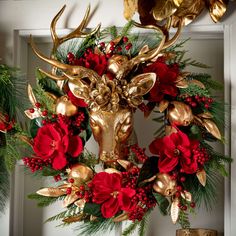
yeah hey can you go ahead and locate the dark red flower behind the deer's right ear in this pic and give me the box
[144,59,179,102]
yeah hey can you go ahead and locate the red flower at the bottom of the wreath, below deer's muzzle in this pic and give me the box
[92,172,135,218]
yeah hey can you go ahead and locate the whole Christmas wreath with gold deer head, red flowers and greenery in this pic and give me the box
[1,4,231,235]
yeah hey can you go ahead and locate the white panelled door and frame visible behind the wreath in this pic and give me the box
[0,0,236,236]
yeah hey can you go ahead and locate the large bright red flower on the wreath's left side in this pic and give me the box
[34,119,83,170]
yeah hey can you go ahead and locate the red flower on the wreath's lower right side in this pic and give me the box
[149,131,199,174]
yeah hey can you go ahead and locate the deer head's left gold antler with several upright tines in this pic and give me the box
[30,5,101,81]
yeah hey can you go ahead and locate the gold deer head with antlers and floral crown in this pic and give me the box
[31,6,182,164]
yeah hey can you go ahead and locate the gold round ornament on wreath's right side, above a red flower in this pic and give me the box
[167,101,194,126]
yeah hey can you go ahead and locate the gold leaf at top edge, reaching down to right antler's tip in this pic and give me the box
[172,0,205,27]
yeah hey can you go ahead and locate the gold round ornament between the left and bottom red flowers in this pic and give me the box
[68,164,93,186]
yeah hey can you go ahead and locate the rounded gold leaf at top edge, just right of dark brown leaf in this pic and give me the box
[152,0,183,21]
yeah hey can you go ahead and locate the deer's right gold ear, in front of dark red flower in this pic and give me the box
[126,73,156,107]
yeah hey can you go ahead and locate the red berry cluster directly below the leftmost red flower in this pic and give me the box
[23,157,52,172]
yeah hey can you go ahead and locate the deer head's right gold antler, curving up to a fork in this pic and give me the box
[116,17,183,79]
